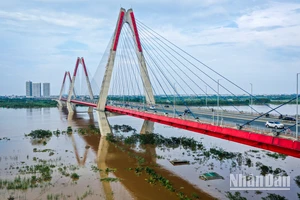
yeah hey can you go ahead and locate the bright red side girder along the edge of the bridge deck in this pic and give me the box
[62,99,300,158]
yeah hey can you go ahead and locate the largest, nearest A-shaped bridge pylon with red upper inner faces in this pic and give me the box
[97,8,155,111]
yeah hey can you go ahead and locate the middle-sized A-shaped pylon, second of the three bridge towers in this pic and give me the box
[67,57,94,113]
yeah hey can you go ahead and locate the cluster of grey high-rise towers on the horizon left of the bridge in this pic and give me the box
[26,81,50,97]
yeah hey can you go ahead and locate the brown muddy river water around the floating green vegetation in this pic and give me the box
[0,108,300,200]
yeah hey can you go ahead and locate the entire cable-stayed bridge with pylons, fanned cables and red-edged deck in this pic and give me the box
[58,8,300,157]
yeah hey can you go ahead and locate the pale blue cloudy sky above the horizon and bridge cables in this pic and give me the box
[0,0,300,95]
